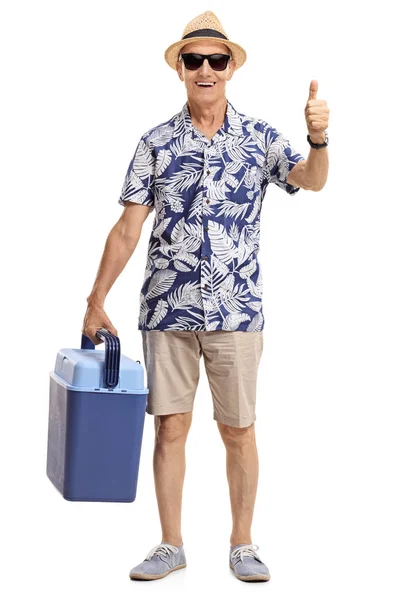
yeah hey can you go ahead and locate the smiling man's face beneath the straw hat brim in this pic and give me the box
[176,40,236,104]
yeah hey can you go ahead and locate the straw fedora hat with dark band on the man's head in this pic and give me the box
[164,10,246,71]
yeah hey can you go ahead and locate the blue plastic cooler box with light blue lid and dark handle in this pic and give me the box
[47,328,149,502]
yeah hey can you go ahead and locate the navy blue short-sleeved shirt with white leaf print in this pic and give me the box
[118,99,305,331]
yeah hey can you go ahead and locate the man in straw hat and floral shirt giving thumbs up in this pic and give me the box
[83,11,329,581]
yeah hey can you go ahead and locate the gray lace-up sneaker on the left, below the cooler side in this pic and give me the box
[129,542,186,579]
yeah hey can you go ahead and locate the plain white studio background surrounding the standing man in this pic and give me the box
[0,0,400,600]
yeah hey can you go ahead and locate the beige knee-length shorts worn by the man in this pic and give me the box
[141,329,263,427]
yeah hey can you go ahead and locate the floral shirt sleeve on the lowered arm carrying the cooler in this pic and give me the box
[118,134,156,212]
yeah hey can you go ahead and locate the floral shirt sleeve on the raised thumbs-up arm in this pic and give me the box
[266,127,306,195]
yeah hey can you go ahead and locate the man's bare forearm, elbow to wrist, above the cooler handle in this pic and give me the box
[87,223,139,306]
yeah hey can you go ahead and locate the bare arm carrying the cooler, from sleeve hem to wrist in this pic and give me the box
[87,202,151,307]
